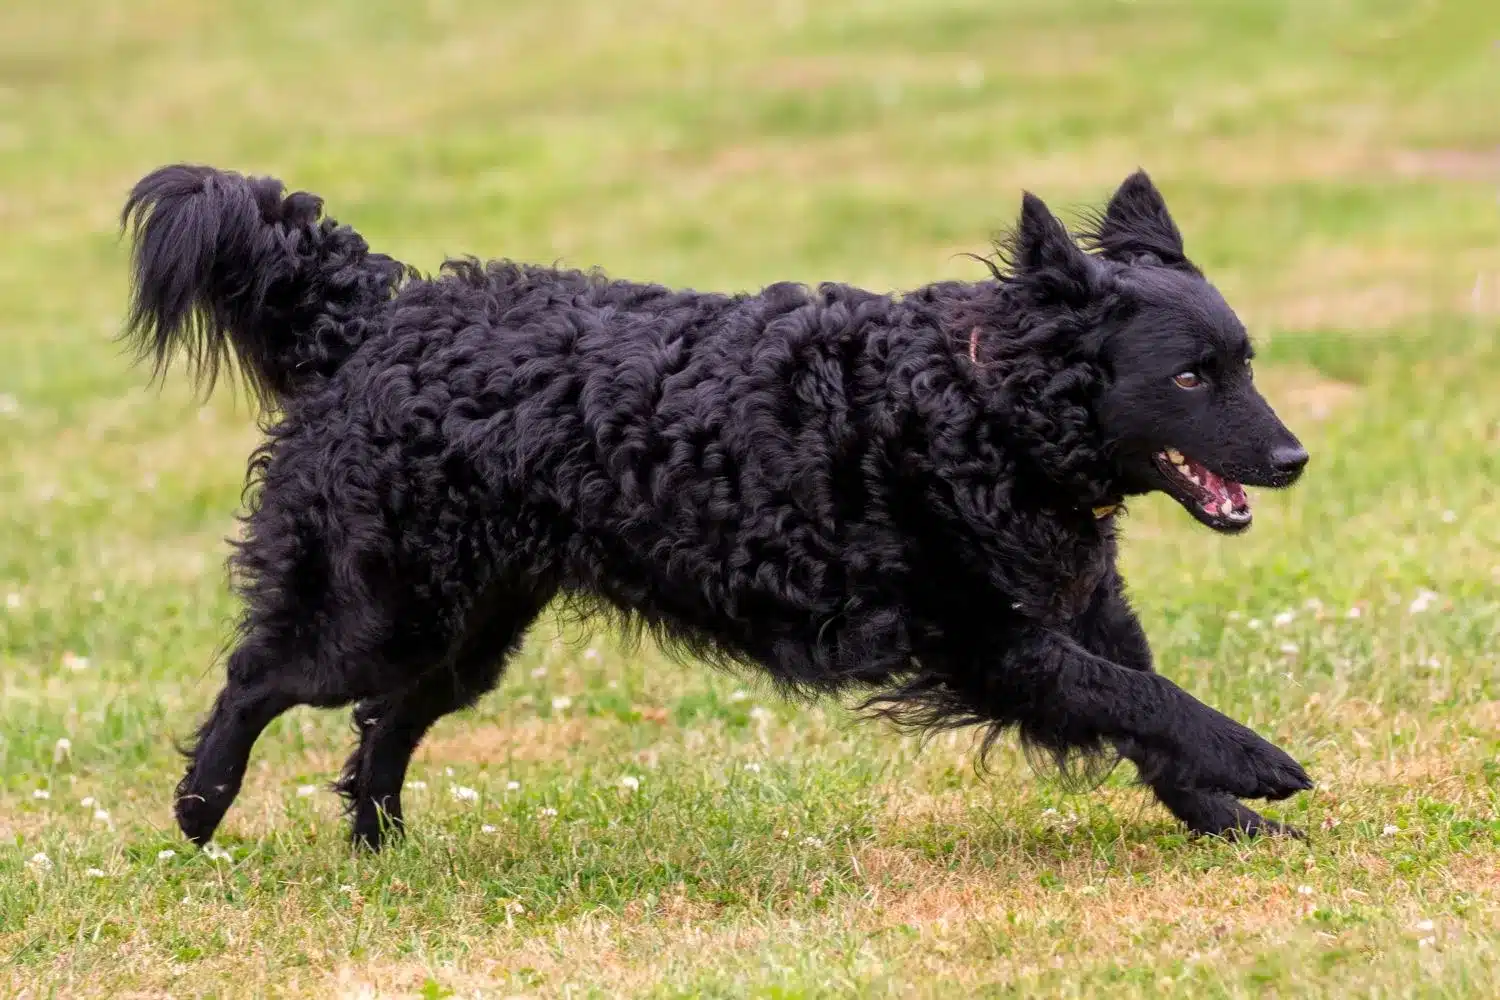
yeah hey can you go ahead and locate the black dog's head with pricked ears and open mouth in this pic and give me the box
[1013,172,1308,532]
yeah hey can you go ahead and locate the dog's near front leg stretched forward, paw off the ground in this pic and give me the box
[984,627,1313,803]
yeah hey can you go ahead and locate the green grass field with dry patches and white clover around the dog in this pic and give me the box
[0,0,1500,999]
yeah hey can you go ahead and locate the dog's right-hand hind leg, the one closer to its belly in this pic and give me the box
[339,597,546,850]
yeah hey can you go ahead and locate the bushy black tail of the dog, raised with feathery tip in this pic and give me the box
[120,165,413,405]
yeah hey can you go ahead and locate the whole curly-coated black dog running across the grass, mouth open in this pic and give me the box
[125,166,1311,846]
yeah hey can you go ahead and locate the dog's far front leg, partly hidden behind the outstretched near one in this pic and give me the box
[1073,573,1302,837]
